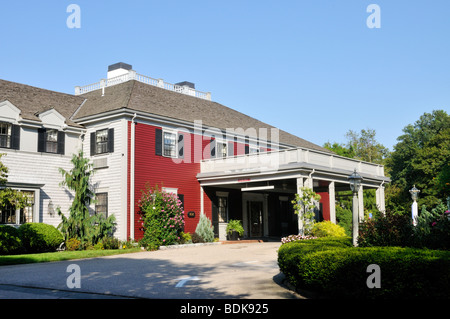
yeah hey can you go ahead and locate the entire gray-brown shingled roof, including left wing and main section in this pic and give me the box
[0,79,332,153]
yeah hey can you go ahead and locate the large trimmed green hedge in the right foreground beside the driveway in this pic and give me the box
[278,238,450,299]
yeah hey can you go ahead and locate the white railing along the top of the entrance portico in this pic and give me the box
[201,148,384,177]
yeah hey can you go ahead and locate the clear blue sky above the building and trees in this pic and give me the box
[0,0,450,150]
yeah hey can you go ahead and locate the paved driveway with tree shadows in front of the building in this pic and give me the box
[0,242,299,299]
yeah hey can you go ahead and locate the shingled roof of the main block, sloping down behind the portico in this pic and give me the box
[74,80,332,153]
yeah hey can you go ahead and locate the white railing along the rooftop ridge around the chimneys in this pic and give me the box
[75,70,211,101]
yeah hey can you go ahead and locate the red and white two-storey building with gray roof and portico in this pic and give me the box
[0,63,389,240]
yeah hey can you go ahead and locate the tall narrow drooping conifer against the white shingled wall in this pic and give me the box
[57,151,115,245]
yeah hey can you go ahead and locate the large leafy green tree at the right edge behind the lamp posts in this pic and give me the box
[386,110,450,207]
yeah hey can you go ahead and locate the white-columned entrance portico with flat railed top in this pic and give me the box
[197,148,389,239]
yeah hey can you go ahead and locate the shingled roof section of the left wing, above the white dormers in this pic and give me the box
[0,79,85,127]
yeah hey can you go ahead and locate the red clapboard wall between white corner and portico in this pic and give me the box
[128,122,212,240]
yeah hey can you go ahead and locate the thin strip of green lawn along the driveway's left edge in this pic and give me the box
[0,248,142,266]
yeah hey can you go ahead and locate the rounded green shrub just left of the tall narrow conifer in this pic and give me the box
[19,223,64,253]
